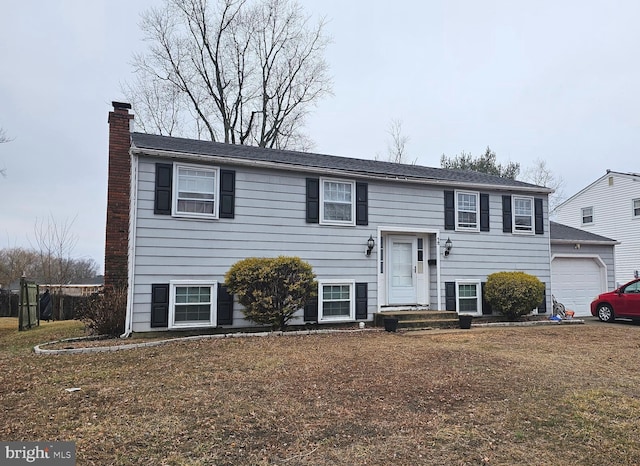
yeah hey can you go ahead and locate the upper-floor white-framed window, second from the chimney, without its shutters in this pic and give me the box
[320,180,355,225]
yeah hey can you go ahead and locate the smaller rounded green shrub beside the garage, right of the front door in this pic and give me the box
[485,272,544,320]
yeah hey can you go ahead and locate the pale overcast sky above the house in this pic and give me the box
[0,0,640,269]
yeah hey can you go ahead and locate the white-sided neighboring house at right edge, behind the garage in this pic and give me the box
[555,170,640,285]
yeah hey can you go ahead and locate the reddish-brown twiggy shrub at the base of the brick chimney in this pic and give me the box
[77,288,127,337]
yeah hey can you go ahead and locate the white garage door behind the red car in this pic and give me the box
[551,257,607,317]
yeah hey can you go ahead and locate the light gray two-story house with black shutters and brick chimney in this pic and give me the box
[105,102,551,332]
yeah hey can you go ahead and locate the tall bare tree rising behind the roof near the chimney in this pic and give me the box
[124,0,331,148]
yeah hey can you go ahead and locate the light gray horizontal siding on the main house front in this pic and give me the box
[133,157,550,331]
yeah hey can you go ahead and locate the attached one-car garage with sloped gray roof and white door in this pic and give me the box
[550,222,619,317]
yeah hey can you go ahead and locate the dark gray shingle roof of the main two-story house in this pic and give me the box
[131,133,549,192]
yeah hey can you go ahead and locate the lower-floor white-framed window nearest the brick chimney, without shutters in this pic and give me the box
[169,281,217,327]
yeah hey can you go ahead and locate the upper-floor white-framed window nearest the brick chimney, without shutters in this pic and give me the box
[173,164,218,218]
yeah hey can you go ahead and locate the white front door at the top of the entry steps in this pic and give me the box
[387,236,417,304]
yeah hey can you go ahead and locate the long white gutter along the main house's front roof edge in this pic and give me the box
[131,145,554,194]
